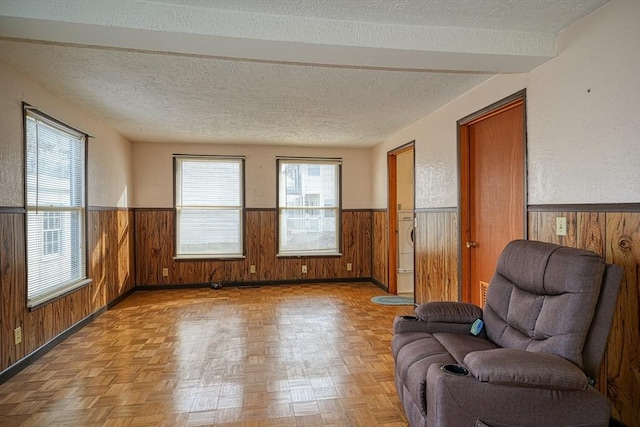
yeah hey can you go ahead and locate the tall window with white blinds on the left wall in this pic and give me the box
[24,105,90,307]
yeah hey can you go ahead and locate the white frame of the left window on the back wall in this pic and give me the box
[174,155,245,260]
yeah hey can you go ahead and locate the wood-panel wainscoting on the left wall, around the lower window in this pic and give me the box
[0,207,135,375]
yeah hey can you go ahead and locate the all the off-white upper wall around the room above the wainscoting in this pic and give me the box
[0,0,640,209]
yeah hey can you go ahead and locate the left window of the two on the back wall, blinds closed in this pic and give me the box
[175,156,244,258]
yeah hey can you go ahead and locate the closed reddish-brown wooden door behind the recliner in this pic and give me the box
[459,94,526,305]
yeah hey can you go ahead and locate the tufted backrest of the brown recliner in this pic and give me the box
[483,240,606,368]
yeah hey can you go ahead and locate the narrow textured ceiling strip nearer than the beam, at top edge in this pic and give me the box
[145,0,605,33]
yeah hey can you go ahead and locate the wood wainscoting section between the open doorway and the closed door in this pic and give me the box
[414,208,459,304]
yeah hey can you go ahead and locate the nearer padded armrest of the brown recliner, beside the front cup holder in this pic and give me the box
[464,348,589,390]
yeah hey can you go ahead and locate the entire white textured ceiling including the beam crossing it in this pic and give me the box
[0,0,606,146]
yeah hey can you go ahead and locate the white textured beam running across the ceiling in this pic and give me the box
[0,0,556,73]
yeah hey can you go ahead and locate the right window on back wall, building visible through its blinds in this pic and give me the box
[278,158,341,256]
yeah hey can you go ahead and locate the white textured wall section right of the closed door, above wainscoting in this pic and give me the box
[527,0,640,204]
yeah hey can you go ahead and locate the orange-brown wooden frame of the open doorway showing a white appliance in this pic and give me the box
[387,139,416,295]
